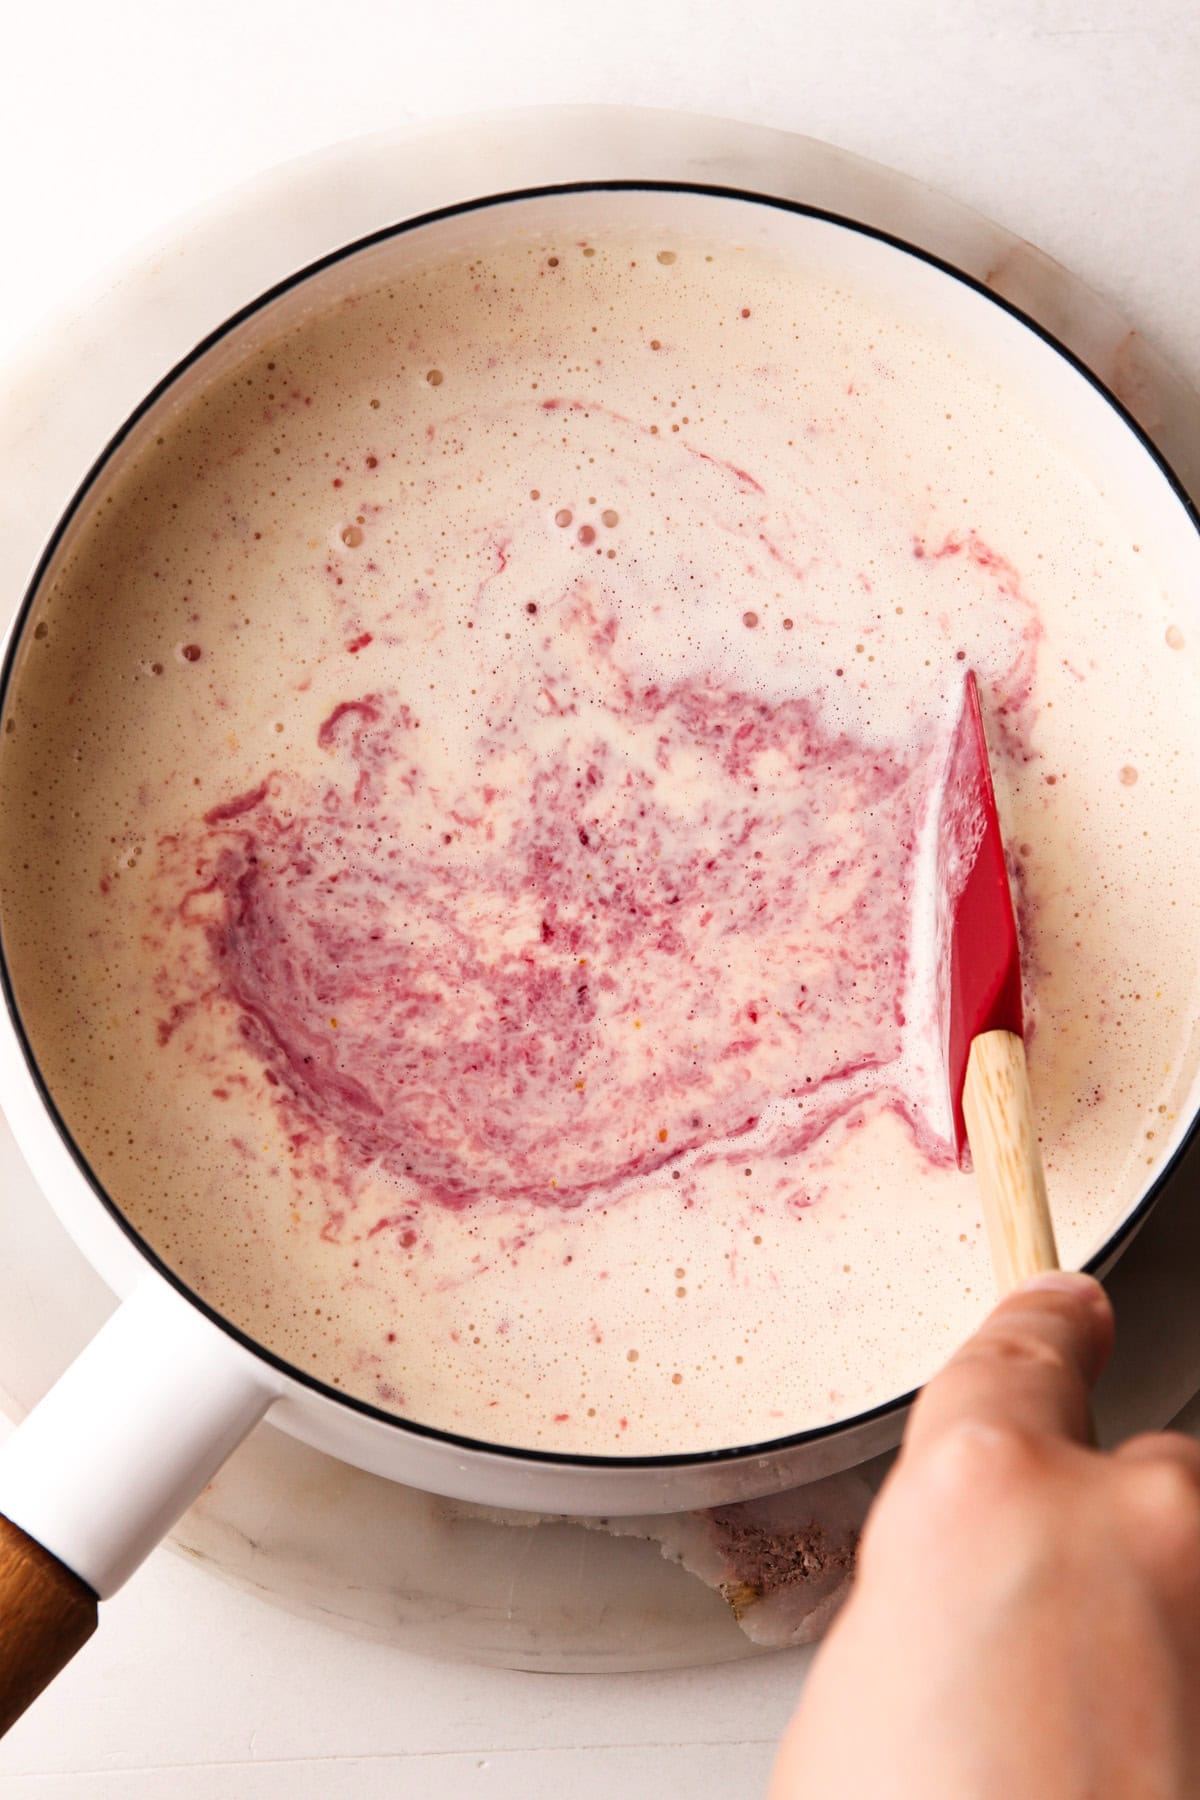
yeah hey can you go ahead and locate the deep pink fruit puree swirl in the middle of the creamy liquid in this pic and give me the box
[147,525,1036,1208]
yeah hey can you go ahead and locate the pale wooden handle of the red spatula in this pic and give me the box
[963,1031,1058,1294]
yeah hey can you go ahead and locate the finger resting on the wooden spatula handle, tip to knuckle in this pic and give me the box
[905,1274,1112,1451]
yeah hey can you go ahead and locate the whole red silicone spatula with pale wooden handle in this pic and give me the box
[937,673,1058,1294]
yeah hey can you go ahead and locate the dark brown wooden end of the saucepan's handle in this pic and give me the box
[0,1517,95,1737]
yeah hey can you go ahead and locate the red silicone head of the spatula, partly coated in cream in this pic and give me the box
[937,671,1024,1166]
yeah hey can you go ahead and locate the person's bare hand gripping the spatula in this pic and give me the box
[770,1274,1200,1800]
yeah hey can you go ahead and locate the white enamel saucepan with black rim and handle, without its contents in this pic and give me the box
[0,171,1200,1724]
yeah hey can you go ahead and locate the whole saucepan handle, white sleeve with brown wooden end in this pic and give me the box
[0,1274,279,1732]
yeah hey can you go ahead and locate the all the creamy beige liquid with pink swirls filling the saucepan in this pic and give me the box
[0,210,1200,1454]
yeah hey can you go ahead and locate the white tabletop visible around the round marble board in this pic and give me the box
[0,0,1200,1800]
